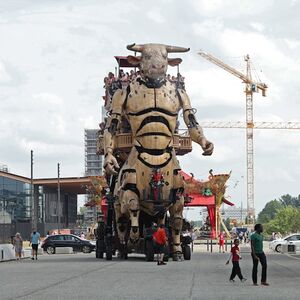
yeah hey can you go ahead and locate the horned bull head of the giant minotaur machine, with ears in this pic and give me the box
[127,44,190,79]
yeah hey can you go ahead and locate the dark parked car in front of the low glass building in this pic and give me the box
[41,234,95,254]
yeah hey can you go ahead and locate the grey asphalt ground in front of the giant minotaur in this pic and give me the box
[0,249,300,300]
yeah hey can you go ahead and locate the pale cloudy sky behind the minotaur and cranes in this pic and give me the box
[0,0,300,219]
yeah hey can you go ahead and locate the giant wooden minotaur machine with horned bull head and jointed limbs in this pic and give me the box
[102,44,213,260]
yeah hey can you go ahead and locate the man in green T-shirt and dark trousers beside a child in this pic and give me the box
[250,224,269,286]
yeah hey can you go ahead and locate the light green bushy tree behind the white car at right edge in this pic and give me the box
[265,206,300,234]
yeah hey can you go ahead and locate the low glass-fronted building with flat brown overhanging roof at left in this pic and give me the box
[0,171,90,242]
